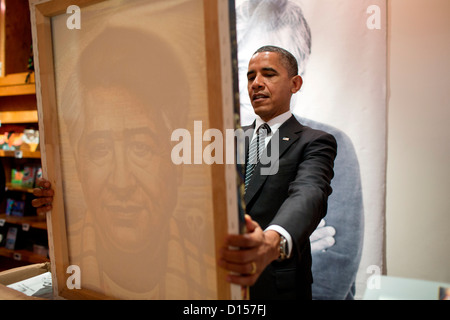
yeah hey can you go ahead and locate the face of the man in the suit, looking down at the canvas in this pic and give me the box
[247,52,301,121]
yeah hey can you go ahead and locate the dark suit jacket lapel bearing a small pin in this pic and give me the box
[244,116,303,203]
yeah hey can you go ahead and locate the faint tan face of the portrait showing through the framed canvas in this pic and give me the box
[77,88,177,252]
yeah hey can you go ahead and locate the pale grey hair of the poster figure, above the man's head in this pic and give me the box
[236,0,311,75]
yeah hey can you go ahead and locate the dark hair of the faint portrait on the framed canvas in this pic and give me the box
[62,27,190,151]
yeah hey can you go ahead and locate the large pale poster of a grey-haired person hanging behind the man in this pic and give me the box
[236,0,386,299]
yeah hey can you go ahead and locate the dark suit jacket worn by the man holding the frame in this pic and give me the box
[243,116,337,299]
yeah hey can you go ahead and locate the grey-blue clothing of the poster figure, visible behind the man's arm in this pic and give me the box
[295,116,364,300]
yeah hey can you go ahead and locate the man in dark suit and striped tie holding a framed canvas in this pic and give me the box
[219,46,337,299]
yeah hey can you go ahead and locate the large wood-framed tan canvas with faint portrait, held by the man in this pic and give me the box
[30,0,244,299]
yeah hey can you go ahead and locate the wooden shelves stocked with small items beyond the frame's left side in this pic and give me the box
[0,0,49,271]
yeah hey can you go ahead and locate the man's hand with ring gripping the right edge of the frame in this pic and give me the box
[218,215,280,286]
